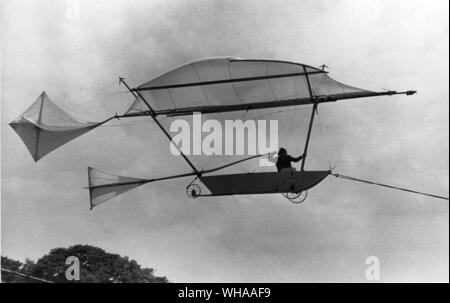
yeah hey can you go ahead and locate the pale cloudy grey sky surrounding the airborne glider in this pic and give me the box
[0,0,449,282]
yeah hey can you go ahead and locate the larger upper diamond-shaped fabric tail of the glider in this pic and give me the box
[9,92,107,162]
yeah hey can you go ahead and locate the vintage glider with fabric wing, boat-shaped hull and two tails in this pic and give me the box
[11,57,430,208]
